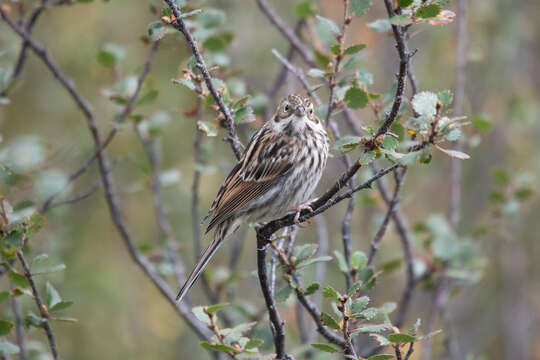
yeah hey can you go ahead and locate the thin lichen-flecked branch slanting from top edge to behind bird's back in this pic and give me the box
[165,0,244,159]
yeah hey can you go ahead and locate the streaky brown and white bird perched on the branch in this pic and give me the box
[176,94,329,302]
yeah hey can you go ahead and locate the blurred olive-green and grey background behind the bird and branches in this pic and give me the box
[0,0,540,360]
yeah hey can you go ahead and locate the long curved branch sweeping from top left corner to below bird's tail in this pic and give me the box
[0,8,215,340]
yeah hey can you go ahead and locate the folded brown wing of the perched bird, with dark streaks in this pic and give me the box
[206,128,297,232]
